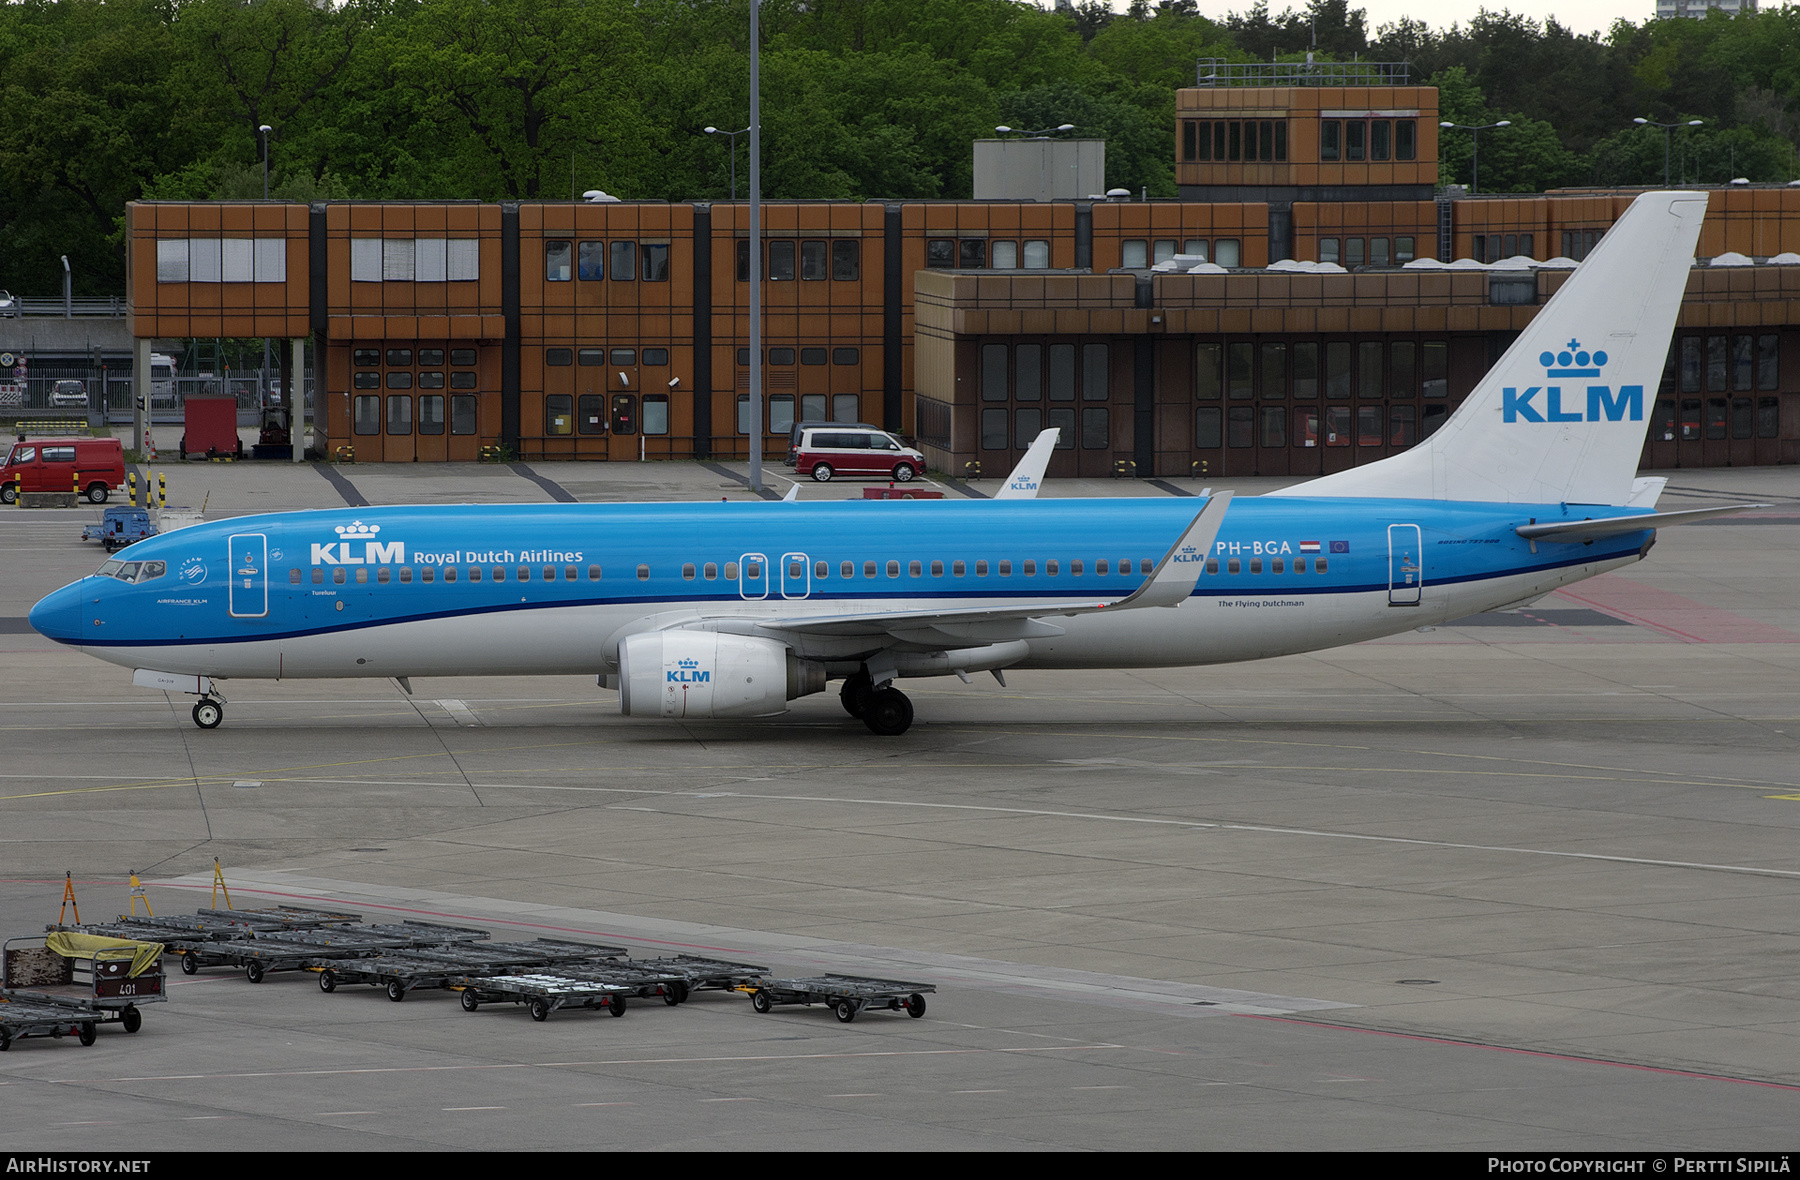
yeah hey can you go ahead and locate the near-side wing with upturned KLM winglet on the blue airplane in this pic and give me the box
[702,491,1231,644]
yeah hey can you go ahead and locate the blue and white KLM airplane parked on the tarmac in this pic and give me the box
[31,192,1742,734]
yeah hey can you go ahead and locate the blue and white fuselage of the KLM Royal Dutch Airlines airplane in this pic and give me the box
[32,498,1654,678]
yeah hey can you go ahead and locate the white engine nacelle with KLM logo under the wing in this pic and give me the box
[619,631,824,718]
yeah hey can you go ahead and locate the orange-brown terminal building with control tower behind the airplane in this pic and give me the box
[128,63,1800,477]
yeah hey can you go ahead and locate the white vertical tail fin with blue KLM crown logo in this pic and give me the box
[1269,192,1706,505]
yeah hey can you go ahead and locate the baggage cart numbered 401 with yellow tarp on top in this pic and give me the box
[0,934,169,1036]
